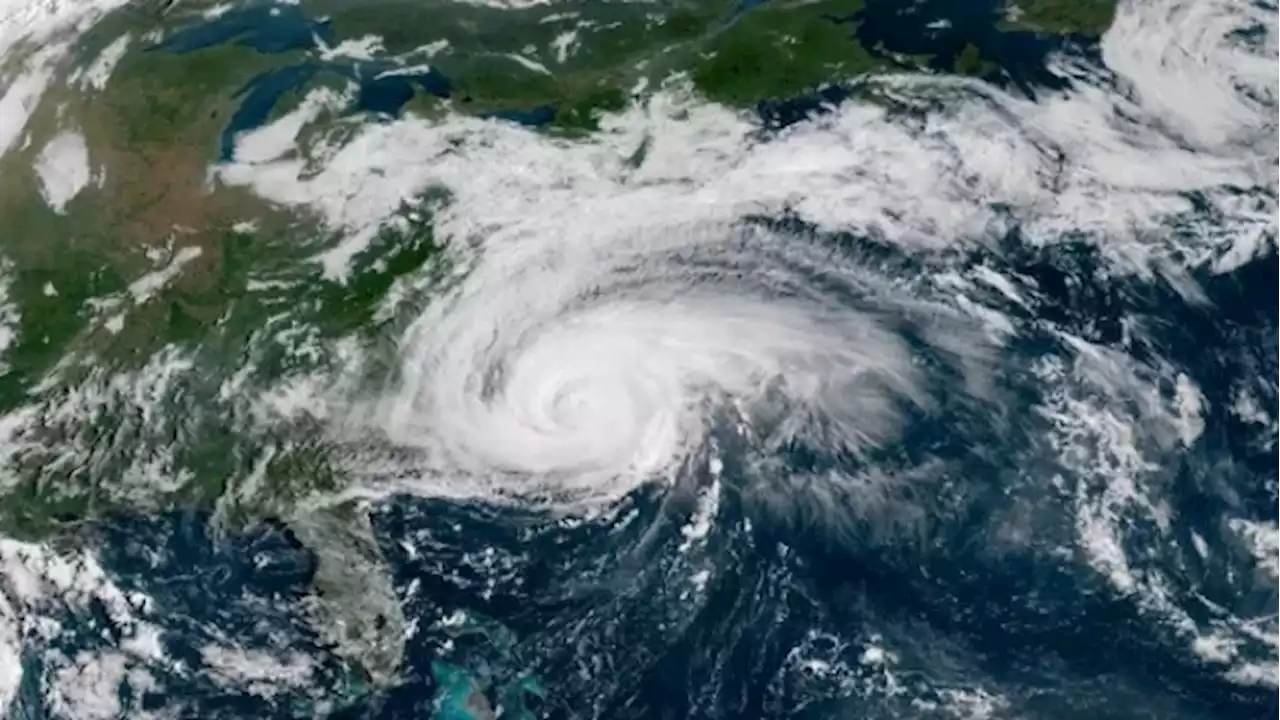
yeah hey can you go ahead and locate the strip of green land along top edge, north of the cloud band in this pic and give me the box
[316,0,1115,125]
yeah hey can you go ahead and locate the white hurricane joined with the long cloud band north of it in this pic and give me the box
[219,1,1280,532]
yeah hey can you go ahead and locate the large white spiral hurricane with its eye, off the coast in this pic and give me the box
[371,215,988,506]
